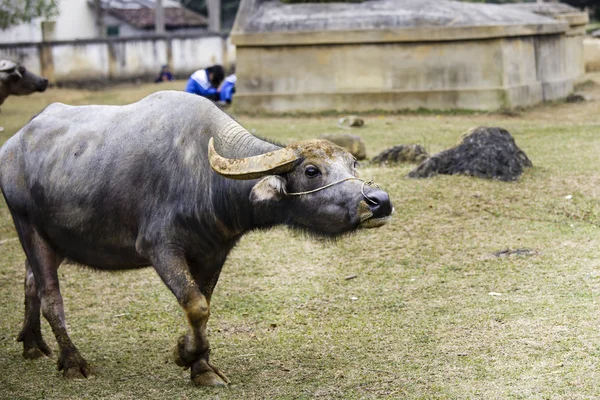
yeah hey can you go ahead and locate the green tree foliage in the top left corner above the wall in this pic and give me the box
[0,0,59,29]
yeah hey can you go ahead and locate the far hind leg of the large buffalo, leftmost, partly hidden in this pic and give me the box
[17,261,52,360]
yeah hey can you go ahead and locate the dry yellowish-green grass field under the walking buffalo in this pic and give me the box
[0,82,600,399]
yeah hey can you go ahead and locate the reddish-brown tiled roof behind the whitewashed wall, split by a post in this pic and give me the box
[107,7,208,29]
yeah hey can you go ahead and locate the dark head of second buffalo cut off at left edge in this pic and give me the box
[0,60,48,105]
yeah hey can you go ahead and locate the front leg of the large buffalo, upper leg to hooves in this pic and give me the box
[154,251,229,386]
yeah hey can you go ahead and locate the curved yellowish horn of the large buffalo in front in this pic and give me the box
[208,138,299,180]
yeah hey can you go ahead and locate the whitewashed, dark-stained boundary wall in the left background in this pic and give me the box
[0,34,235,84]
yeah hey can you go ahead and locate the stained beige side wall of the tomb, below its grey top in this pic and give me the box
[236,35,573,112]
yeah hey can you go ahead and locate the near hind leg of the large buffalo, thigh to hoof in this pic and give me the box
[13,214,90,378]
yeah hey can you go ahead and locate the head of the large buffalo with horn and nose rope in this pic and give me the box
[209,139,394,236]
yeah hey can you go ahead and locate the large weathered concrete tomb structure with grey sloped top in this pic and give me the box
[231,0,583,113]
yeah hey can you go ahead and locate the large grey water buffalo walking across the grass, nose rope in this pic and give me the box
[0,91,393,385]
